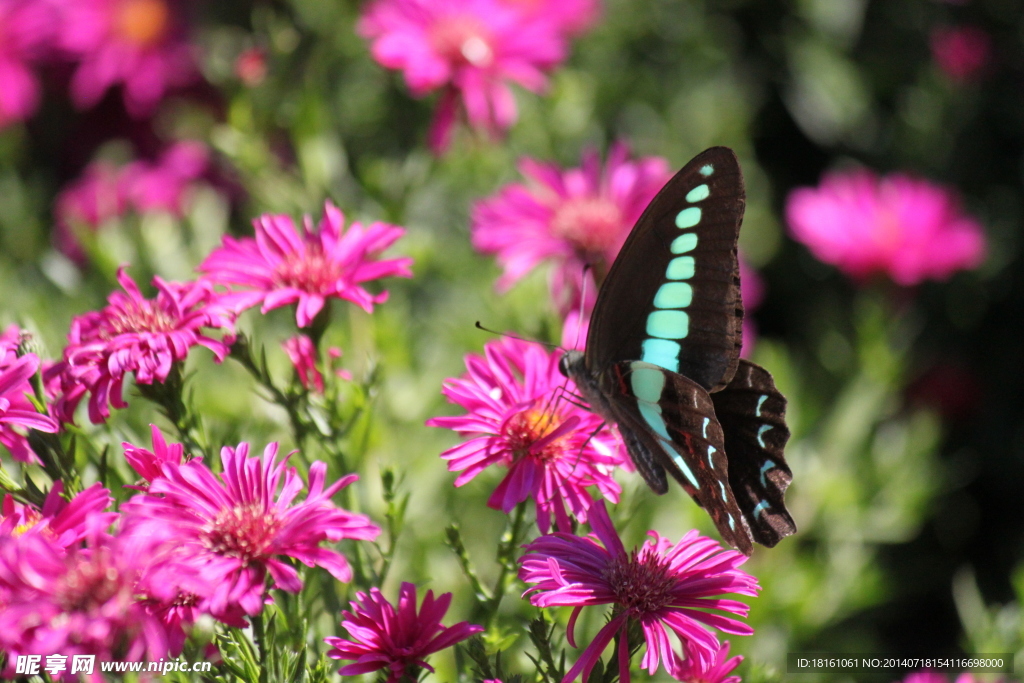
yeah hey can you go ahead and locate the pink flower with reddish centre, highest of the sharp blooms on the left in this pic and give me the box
[199,202,413,328]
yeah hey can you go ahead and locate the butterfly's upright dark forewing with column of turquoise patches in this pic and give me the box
[587,147,744,391]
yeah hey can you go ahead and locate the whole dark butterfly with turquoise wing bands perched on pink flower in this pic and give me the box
[560,147,797,555]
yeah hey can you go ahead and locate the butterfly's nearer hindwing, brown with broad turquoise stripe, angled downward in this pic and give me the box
[602,360,753,555]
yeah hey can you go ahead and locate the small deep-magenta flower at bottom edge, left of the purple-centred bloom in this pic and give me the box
[325,582,483,683]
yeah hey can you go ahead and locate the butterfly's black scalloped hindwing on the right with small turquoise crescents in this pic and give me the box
[711,359,797,547]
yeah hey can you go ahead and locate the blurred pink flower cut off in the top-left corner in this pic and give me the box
[0,0,54,129]
